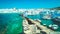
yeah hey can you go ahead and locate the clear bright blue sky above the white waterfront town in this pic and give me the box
[0,0,60,8]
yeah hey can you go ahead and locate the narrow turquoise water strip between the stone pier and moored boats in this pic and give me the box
[27,15,53,25]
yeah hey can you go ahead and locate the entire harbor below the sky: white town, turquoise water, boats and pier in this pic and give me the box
[0,8,60,34]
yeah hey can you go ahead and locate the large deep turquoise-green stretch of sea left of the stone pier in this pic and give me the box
[0,13,23,34]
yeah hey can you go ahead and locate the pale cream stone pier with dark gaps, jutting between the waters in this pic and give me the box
[23,13,57,34]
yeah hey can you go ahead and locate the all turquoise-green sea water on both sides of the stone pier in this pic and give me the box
[0,13,60,34]
